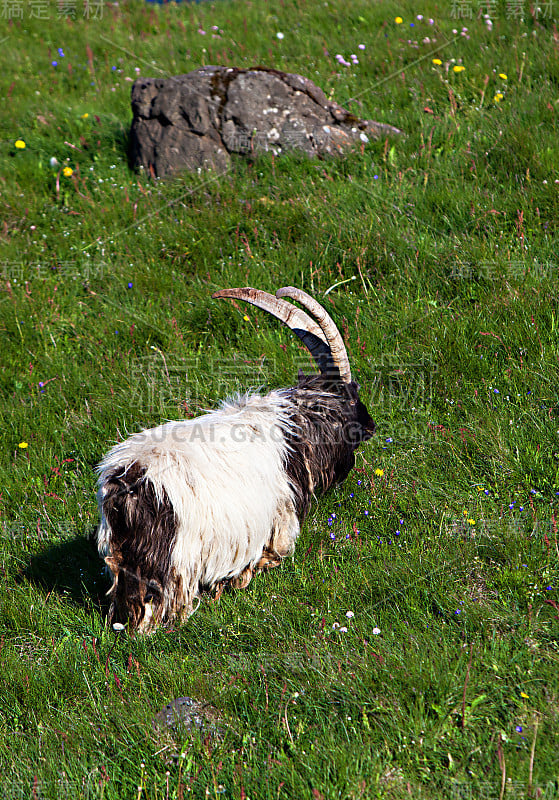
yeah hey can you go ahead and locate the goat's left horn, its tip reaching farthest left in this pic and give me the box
[212,286,332,372]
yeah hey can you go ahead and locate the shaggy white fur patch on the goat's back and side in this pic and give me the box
[98,392,299,607]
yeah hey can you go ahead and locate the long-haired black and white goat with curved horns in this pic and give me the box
[97,286,375,633]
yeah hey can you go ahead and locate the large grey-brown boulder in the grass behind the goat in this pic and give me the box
[130,67,401,178]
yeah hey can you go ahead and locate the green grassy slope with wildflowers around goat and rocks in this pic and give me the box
[0,0,559,800]
